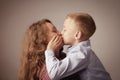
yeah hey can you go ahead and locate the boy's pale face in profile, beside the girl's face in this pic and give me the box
[61,18,78,45]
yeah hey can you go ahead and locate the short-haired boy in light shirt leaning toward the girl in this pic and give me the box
[45,13,111,80]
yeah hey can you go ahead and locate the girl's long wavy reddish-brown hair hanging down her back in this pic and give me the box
[19,19,51,80]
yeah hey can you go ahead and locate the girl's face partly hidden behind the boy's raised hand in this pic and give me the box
[46,23,59,42]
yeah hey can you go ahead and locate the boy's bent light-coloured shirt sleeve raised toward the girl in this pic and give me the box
[45,50,87,80]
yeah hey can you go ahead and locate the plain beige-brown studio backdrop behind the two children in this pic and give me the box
[0,0,120,80]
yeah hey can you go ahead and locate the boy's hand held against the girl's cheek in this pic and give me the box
[47,35,63,52]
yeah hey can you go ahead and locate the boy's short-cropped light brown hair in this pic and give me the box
[67,13,96,40]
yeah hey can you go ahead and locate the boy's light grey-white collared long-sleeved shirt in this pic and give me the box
[45,40,111,80]
